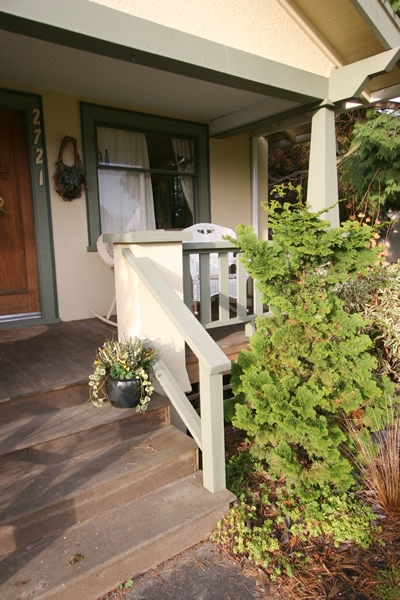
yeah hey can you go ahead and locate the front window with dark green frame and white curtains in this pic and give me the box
[81,103,210,250]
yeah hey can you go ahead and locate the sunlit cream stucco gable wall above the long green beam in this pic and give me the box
[90,0,334,75]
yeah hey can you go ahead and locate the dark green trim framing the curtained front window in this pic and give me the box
[80,102,211,251]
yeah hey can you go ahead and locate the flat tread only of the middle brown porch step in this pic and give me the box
[0,425,197,528]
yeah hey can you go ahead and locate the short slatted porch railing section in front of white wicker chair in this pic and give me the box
[183,242,264,335]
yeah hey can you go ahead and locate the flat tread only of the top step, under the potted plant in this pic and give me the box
[0,393,169,456]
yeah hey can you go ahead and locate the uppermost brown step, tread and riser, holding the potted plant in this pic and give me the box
[0,386,170,483]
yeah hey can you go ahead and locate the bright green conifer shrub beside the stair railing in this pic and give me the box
[231,186,390,494]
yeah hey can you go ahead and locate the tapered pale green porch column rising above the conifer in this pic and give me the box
[307,101,339,227]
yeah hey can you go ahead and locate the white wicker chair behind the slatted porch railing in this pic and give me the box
[183,223,237,314]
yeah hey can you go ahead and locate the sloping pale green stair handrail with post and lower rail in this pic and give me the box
[122,248,231,493]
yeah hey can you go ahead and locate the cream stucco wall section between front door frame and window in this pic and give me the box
[41,91,114,321]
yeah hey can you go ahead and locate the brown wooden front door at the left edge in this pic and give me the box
[0,109,40,315]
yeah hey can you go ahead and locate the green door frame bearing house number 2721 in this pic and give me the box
[0,89,60,329]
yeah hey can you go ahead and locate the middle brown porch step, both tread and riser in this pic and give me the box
[0,425,198,555]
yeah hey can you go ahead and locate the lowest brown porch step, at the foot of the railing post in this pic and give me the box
[0,471,234,600]
